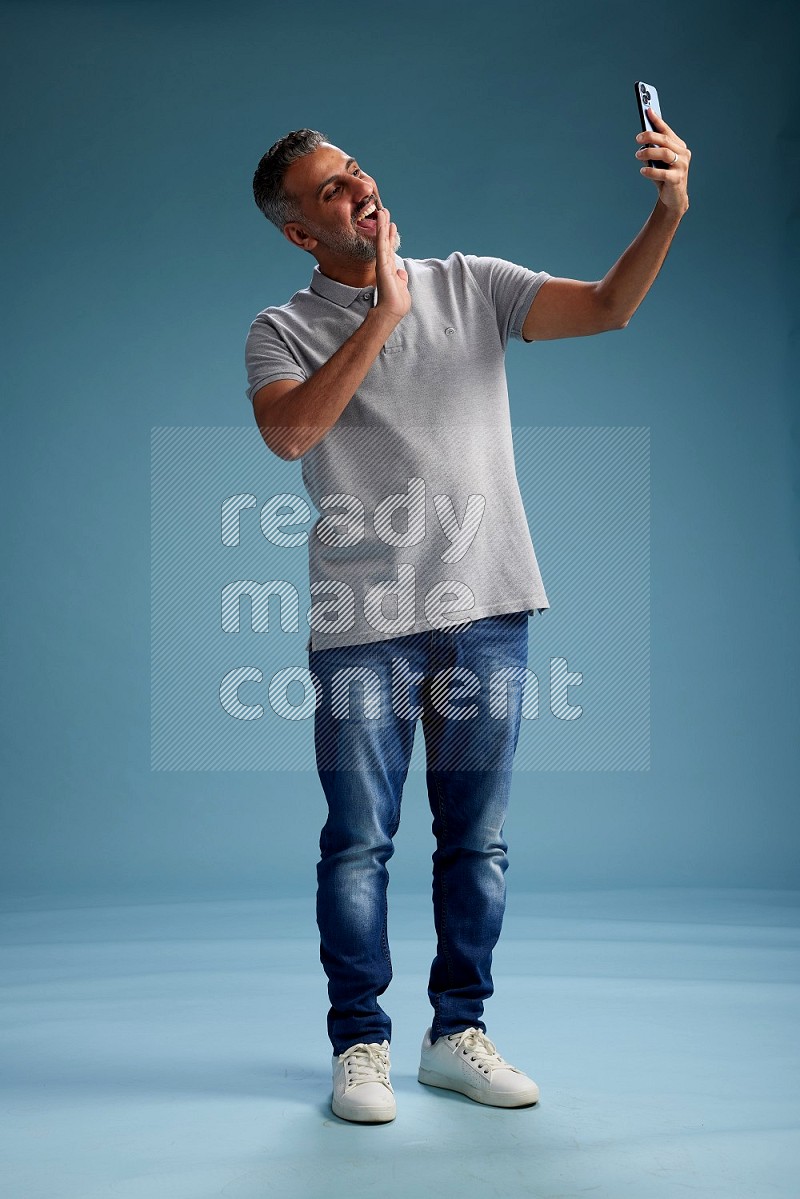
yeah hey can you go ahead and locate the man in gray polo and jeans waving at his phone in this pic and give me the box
[246,110,691,1122]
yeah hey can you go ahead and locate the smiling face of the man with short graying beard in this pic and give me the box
[283,141,401,263]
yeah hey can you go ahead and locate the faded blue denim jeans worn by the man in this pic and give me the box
[308,611,528,1054]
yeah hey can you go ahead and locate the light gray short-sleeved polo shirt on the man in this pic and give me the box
[245,252,551,650]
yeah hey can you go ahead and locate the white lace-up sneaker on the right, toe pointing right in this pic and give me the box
[417,1029,539,1108]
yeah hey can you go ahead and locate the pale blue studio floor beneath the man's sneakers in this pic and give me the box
[0,888,800,1199]
